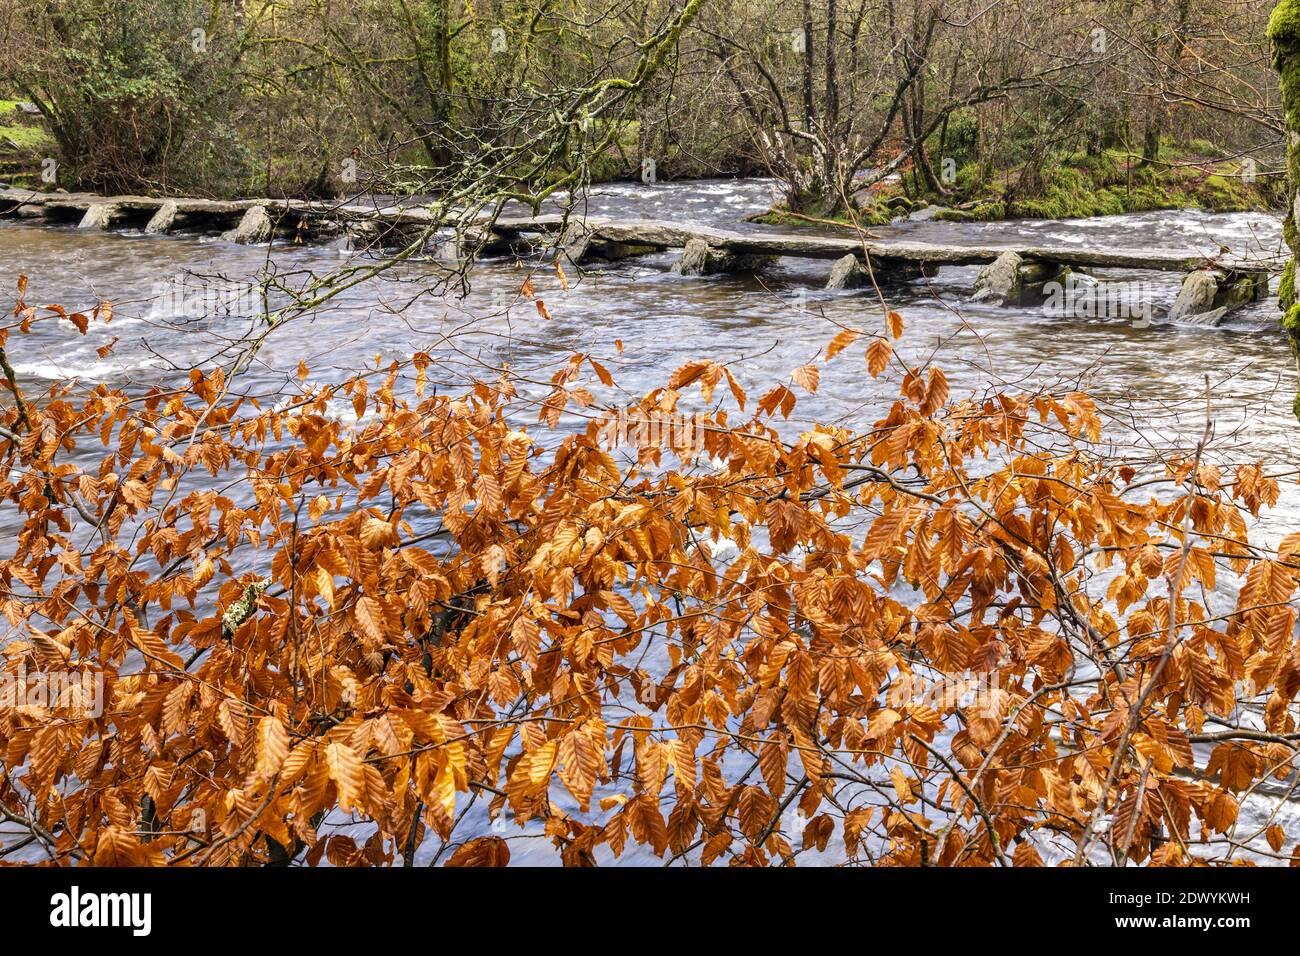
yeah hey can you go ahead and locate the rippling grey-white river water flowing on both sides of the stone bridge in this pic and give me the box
[0,179,1300,858]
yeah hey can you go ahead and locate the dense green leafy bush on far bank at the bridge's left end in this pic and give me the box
[3,0,247,191]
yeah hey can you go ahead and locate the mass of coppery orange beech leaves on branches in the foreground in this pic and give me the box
[0,278,1300,865]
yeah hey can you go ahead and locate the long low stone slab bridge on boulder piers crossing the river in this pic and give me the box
[0,189,1284,325]
